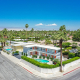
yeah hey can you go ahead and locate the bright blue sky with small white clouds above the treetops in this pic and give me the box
[0,0,80,30]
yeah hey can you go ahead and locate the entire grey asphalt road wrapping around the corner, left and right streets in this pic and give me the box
[0,54,80,80]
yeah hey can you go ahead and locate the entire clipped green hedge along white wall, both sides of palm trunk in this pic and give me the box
[21,56,80,68]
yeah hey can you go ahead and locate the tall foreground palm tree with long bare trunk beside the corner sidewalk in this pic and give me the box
[57,31,67,72]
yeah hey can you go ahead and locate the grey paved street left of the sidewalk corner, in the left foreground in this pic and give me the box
[0,54,55,80]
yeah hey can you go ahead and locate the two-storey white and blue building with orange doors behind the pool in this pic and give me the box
[23,45,60,59]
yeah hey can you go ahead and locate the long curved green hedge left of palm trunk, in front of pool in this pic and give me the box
[21,56,59,68]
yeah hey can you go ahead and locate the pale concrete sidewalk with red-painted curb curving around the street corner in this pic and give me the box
[1,51,80,78]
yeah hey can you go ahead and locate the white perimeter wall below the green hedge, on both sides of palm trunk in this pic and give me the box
[21,59,80,73]
